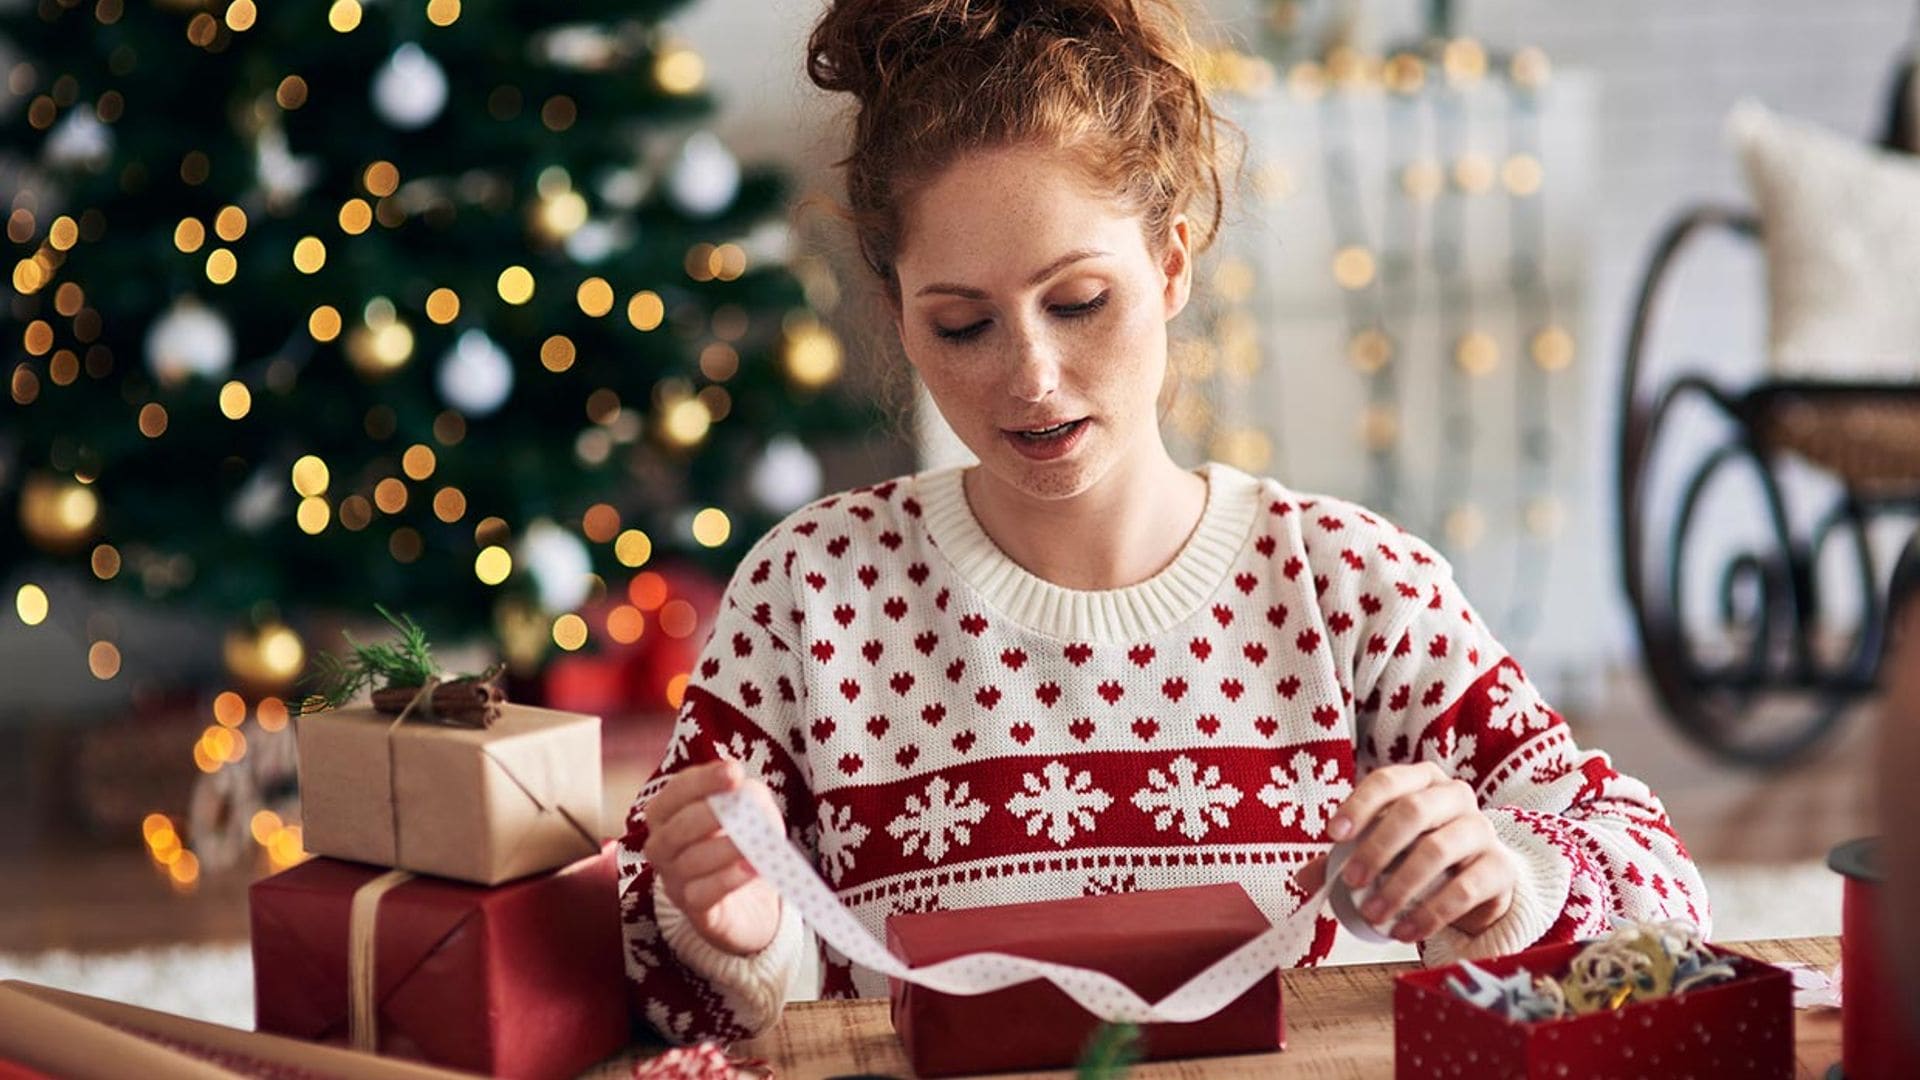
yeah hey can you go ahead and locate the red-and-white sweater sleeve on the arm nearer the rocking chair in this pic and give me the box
[1356,538,1711,965]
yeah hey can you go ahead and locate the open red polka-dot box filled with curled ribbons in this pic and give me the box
[1394,942,1793,1080]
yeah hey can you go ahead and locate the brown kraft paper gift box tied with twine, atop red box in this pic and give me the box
[296,703,601,884]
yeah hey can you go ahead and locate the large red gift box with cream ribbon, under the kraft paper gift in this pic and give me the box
[248,846,632,1080]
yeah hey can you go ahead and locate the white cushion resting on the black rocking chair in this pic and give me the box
[1726,102,1920,380]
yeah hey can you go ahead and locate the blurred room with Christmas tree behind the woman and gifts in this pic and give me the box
[0,0,1920,1024]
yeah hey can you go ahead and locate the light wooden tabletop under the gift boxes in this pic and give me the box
[739,938,1839,1080]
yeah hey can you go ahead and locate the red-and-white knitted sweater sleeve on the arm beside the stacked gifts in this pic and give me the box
[618,555,812,1043]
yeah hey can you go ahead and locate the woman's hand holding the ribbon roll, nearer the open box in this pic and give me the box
[1327,761,1519,942]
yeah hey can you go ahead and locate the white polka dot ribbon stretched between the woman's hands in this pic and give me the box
[707,790,1346,1022]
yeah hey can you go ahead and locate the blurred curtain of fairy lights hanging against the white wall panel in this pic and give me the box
[1169,27,1574,642]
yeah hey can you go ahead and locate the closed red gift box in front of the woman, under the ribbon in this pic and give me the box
[887,884,1286,1076]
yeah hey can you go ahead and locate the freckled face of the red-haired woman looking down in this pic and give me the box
[895,148,1190,498]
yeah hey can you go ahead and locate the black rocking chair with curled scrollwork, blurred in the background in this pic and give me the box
[1619,61,1920,767]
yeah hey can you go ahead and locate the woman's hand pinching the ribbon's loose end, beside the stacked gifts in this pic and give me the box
[641,759,787,957]
